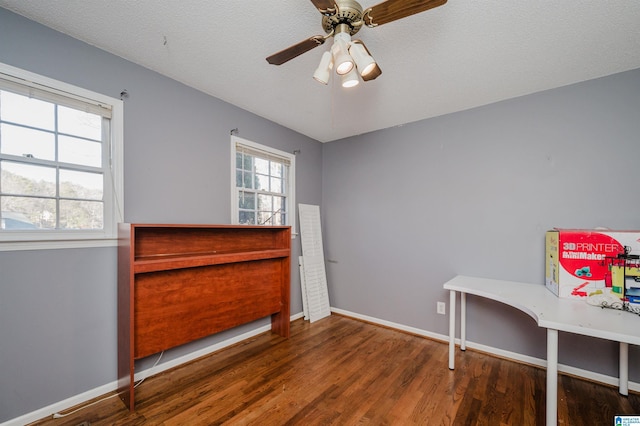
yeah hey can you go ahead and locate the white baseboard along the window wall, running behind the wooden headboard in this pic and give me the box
[0,312,303,426]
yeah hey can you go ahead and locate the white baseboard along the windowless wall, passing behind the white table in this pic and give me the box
[331,308,640,392]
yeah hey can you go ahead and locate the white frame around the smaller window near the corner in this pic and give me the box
[230,135,296,238]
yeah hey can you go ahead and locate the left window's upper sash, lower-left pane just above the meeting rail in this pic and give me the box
[0,123,56,160]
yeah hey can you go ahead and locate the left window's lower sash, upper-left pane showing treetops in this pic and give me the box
[0,161,56,197]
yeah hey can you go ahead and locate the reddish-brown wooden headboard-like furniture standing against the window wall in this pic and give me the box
[118,223,291,411]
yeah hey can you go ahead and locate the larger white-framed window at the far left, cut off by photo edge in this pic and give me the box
[0,64,123,250]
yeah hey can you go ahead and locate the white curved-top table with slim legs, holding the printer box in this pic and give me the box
[444,275,640,426]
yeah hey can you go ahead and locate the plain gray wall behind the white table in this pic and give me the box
[322,70,640,381]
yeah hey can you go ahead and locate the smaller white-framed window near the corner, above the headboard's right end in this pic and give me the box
[231,136,295,233]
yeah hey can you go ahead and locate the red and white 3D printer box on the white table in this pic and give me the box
[545,229,640,299]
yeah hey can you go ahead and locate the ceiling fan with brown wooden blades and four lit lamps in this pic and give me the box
[267,0,447,87]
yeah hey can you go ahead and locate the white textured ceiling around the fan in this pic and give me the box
[0,0,640,142]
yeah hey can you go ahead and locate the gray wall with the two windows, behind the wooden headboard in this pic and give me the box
[0,8,322,423]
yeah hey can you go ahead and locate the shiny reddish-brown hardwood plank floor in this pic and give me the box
[34,314,640,426]
